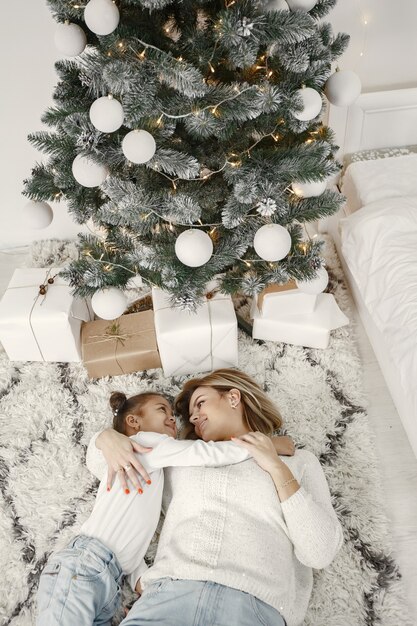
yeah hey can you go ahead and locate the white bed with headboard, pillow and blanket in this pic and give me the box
[319,88,417,458]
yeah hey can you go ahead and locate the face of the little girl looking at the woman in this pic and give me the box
[126,396,177,438]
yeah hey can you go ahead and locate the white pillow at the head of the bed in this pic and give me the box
[342,154,417,214]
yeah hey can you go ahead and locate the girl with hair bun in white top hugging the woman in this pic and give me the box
[37,392,294,626]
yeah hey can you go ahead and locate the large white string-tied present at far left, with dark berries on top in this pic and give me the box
[0,267,92,361]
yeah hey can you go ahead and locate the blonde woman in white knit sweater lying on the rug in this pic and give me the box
[90,369,343,626]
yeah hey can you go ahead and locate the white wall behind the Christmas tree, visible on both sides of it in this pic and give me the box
[0,0,417,248]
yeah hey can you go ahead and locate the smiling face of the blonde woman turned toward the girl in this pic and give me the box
[189,387,249,441]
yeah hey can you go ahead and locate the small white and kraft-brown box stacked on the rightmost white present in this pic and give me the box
[251,280,317,318]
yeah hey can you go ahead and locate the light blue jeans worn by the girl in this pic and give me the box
[36,535,123,626]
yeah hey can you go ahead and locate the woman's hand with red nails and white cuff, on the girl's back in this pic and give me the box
[86,428,152,489]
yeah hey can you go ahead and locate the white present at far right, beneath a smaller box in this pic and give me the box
[252,293,349,348]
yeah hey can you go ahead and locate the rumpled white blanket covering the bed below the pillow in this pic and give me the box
[340,194,417,416]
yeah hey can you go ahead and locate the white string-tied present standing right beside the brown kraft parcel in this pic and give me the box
[152,285,238,376]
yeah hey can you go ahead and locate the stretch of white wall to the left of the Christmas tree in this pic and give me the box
[0,0,83,248]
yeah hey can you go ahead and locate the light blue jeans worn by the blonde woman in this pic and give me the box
[120,578,285,626]
